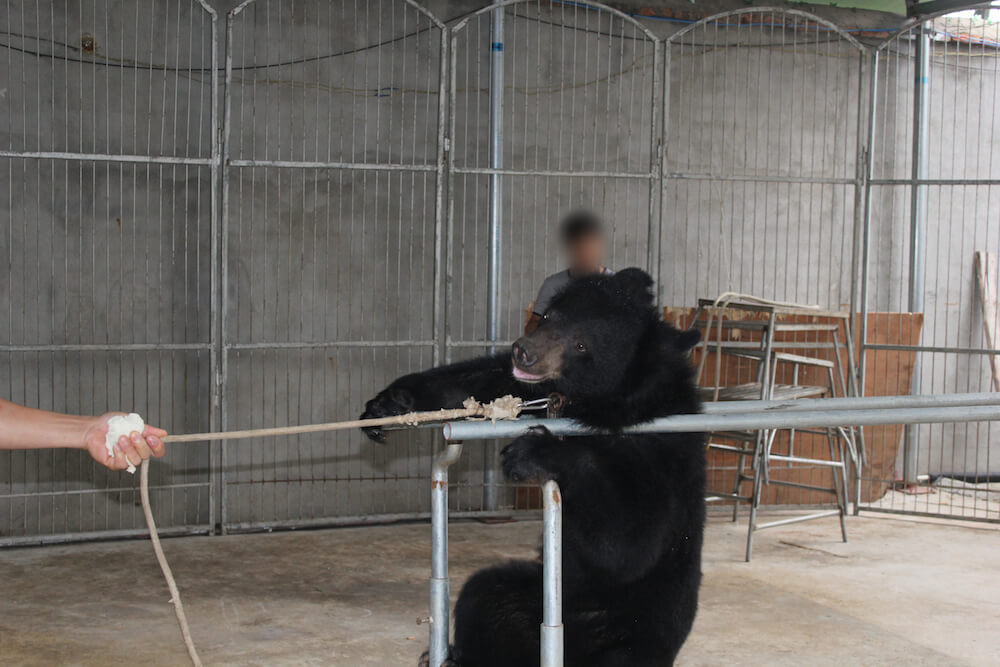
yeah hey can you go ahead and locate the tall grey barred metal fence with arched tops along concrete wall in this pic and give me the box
[0,0,1000,544]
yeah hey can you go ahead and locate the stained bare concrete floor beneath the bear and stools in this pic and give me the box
[0,515,1000,666]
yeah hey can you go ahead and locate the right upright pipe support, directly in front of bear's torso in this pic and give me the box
[541,480,563,667]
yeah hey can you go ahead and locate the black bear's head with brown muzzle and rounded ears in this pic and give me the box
[511,268,700,429]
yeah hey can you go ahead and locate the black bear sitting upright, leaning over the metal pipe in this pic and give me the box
[363,269,705,667]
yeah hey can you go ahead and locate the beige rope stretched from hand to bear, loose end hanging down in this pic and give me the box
[139,395,528,667]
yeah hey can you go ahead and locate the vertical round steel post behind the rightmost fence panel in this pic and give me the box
[903,23,931,485]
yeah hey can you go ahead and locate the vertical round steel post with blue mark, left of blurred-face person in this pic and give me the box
[483,0,504,510]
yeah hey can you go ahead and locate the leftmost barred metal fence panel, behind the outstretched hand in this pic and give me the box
[0,0,218,545]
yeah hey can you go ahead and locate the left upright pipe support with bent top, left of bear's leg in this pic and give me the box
[430,442,462,667]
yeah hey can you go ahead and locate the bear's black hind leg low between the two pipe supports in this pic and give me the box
[452,561,542,667]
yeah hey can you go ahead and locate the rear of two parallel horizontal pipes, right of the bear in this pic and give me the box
[703,392,1000,414]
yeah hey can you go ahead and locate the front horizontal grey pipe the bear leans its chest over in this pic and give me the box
[442,399,1000,441]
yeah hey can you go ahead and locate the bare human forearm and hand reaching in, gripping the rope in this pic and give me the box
[0,399,167,470]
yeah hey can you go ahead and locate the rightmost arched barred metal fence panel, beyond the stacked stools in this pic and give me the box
[861,7,1000,521]
